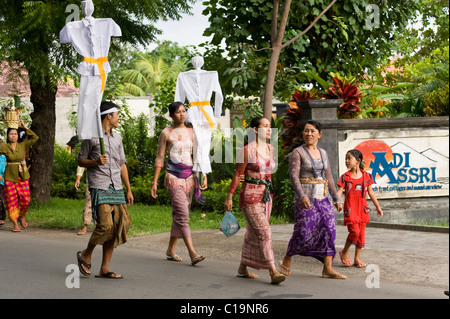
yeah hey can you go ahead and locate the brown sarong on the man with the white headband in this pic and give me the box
[89,204,130,247]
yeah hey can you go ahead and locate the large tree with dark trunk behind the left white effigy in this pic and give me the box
[0,0,195,202]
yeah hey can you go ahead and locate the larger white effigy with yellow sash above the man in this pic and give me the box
[59,0,122,140]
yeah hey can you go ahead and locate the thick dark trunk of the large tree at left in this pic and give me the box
[30,80,56,203]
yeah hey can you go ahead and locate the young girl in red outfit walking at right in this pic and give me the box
[338,150,383,268]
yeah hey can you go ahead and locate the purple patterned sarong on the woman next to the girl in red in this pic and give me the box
[286,198,336,262]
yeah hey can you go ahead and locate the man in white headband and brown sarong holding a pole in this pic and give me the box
[77,102,133,279]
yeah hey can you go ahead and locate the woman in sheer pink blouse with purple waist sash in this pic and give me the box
[151,102,207,265]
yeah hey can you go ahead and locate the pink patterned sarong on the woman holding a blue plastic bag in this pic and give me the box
[241,201,275,269]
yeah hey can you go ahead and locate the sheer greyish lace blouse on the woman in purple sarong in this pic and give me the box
[289,145,338,203]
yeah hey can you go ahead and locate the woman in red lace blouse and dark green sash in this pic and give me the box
[225,118,286,284]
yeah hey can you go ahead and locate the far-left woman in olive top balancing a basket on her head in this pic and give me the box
[0,121,39,232]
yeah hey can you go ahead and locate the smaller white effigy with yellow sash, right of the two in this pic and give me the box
[175,56,223,176]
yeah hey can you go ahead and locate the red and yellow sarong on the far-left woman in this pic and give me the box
[4,177,31,222]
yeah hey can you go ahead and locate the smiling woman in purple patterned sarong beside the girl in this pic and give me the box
[281,121,346,279]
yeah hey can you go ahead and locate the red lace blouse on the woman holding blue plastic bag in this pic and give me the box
[229,142,275,210]
